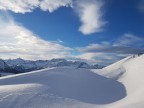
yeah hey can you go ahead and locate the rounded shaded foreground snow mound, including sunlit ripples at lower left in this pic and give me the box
[0,68,126,108]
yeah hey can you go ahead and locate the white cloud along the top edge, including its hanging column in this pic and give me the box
[0,0,106,35]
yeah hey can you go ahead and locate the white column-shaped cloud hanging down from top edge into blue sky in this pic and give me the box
[75,0,106,35]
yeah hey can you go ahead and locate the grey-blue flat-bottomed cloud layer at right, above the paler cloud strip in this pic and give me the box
[79,34,144,54]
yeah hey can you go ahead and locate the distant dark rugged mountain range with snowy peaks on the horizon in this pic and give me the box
[0,58,104,74]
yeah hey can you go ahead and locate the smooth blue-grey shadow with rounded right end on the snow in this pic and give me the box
[0,68,126,104]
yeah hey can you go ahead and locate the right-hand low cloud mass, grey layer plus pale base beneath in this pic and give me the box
[78,34,144,65]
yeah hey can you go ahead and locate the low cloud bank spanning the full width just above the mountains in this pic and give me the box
[0,14,144,64]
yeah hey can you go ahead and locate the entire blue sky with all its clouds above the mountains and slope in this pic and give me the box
[0,0,144,65]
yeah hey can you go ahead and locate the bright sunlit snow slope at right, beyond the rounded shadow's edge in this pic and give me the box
[95,55,144,108]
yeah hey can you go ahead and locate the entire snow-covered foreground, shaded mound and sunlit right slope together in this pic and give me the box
[0,55,144,108]
